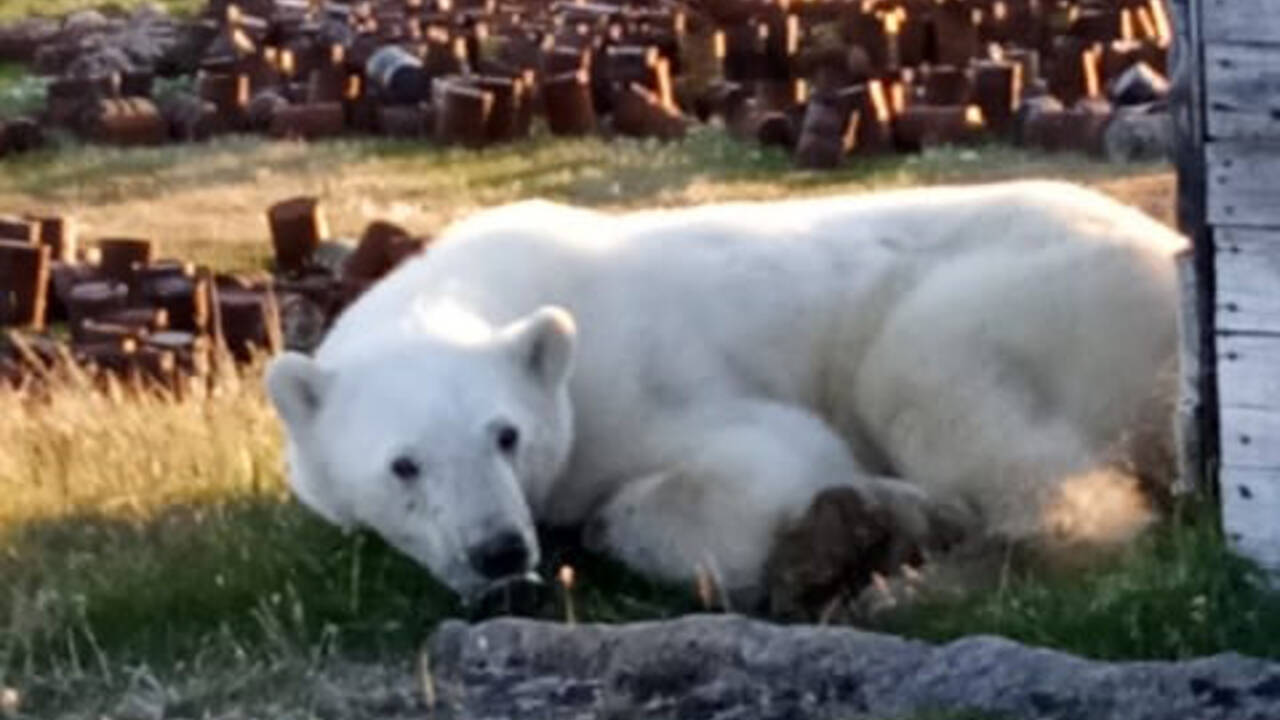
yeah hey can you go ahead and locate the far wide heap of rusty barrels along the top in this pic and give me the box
[0,0,1171,167]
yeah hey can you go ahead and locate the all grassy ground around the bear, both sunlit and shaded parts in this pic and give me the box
[0,132,1280,717]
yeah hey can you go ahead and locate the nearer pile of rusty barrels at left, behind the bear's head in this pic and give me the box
[0,197,426,393]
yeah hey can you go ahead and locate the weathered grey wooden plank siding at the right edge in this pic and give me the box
[1193,0,1280,570]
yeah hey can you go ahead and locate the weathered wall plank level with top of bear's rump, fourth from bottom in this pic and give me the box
[1213,228,1280,333]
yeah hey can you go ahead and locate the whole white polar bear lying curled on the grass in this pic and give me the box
[266,182,1185,596]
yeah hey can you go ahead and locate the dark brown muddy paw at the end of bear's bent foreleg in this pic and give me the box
[764,487,922,620]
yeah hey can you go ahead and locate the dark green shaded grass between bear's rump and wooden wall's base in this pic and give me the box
[874,501,1280,660]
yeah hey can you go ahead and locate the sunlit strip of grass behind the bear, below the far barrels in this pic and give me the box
[0,131,1170,269]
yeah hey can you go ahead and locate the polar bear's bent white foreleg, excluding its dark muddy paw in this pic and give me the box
[585,401,860,597]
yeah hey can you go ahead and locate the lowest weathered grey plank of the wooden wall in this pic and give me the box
[1220,466,1280,570]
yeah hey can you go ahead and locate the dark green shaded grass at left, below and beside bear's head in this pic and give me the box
[0,496,696,671]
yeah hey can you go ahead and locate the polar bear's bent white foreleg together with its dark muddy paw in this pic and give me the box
[586,402,961,605]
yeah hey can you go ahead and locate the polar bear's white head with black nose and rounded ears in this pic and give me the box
[266,307,576,598]
